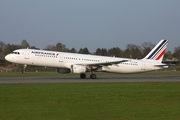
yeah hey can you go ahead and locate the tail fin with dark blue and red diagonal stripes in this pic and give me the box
[143,40,168,63]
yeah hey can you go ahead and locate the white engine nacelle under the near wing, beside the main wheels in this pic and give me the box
[71,65,86,73]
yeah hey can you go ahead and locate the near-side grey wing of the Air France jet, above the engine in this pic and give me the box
[79,60,128,67]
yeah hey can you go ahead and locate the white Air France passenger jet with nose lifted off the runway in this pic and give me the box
[5,40,168,79]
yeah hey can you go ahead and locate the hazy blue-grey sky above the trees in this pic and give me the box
[0,0,180,52]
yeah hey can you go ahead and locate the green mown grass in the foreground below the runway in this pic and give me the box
[0,83,180,120]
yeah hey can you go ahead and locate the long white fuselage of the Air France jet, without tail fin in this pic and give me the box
[6,49,166,73]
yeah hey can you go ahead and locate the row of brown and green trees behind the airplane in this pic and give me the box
[0,40,180,60]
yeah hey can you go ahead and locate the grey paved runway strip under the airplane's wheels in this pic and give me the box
[0,76,180,84]
